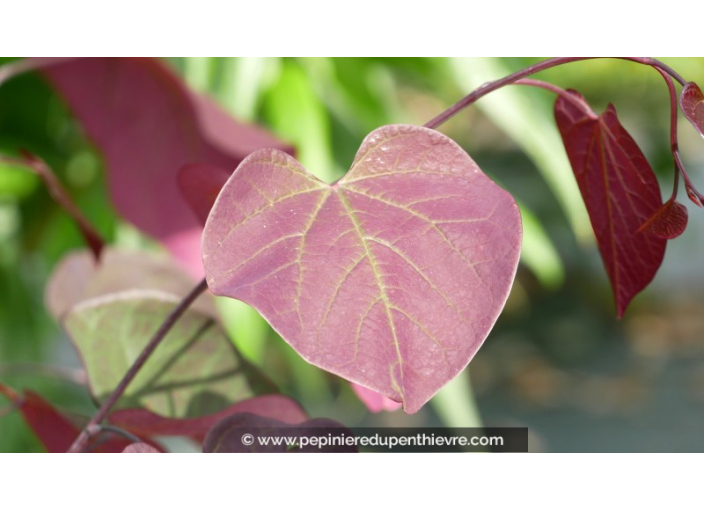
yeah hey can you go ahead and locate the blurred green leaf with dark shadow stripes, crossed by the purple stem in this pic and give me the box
[64,291,275,418]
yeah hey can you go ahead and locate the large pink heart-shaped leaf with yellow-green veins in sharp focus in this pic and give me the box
[202,126,521,413]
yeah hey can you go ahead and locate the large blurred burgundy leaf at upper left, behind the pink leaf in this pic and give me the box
[37,58,291,272]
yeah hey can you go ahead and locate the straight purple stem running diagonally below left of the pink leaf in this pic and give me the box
[68,278,208,453]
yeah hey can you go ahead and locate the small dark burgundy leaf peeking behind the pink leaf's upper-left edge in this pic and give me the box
[178,163,230,225]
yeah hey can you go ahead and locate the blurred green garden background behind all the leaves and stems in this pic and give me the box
[0,58,704,452]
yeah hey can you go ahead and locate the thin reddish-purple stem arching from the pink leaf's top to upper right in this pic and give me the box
[424,57,687,129]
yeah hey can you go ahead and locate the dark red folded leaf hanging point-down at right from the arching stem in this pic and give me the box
[555,91,666,317]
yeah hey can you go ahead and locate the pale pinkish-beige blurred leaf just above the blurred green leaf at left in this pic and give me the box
[45,248,217,320]
